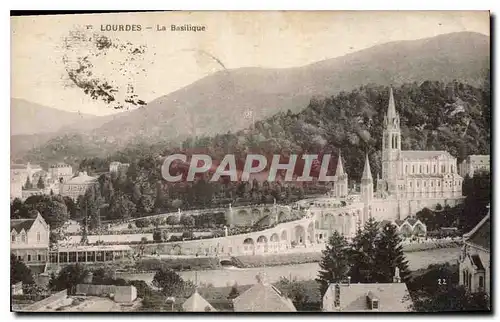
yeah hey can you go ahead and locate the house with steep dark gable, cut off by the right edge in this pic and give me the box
[459,211,491,296]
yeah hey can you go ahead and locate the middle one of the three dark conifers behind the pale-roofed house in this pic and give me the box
[349,217,379,283]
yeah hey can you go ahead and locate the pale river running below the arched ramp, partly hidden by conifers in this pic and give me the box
[117,247,460,287]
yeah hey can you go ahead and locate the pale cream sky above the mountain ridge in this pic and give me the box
[11,11,490,115]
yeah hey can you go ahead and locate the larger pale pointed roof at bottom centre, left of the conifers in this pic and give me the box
[233,273,297,312]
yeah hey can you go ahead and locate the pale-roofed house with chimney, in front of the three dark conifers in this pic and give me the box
[323,269,412,312]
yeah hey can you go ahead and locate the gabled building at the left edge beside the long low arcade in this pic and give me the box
[10,213,50,266]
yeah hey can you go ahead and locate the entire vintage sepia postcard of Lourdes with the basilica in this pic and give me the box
[10,11,492,314]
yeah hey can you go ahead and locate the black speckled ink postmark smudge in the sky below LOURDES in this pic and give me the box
[62,28,146,109]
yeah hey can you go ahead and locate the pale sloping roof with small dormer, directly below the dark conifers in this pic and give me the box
[327,283,412,312]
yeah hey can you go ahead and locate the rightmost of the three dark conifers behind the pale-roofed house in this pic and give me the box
[372,223,410,283]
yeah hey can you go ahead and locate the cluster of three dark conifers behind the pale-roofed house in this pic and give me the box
[316,218,409,295]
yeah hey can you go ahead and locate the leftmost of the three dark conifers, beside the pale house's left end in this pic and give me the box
[316,231,350,296]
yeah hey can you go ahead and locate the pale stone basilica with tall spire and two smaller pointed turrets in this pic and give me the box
[310,89,464,238]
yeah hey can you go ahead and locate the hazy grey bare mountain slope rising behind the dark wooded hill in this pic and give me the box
[15,32,490,164]
